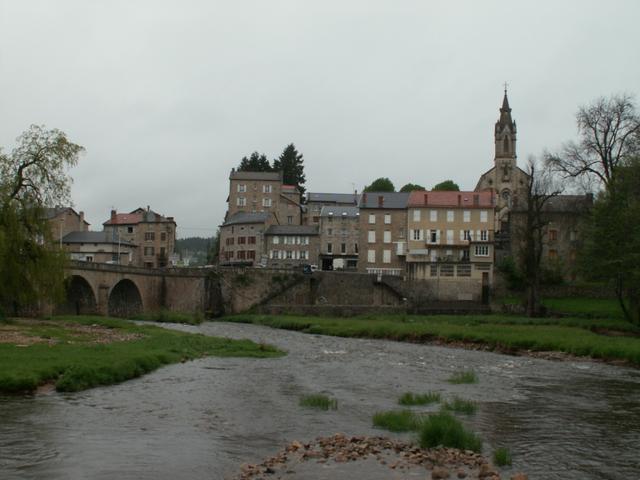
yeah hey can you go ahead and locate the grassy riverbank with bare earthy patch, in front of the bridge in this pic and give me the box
[0,316,283,393]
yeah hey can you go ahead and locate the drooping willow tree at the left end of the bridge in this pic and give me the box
[0,125,83,310]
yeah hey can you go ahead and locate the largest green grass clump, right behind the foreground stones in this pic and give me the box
[419,412,482,453]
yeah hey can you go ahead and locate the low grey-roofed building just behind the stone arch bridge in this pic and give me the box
[62,231,138,265]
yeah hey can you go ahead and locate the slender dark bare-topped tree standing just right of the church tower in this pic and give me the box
[513,159,561,317]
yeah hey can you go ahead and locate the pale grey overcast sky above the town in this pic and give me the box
[0,0,640,237]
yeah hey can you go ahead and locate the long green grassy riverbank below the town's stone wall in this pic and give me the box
[223,315,640,365]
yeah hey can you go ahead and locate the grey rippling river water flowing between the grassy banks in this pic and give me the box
[0,323,640,480]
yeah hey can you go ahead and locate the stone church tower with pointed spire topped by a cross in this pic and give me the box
[475,89,528,222]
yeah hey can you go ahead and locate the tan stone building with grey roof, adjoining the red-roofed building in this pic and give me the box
[358,192,409,276]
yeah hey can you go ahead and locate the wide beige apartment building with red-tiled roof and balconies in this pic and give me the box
[406,191,496,300]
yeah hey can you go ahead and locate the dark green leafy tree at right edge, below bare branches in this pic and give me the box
[580,158,640,324]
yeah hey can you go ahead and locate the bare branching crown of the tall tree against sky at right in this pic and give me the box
[546,95,640,187]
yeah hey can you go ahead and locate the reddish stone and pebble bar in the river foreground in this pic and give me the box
[234,433,528,480]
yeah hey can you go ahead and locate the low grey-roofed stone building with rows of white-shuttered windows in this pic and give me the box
[264,225,320,268]
